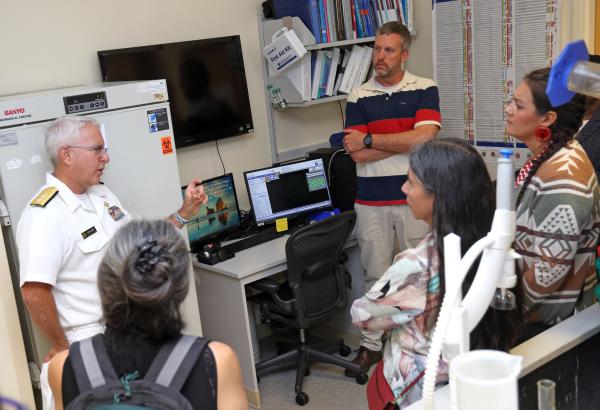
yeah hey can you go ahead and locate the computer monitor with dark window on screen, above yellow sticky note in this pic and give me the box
[244,158,331,225]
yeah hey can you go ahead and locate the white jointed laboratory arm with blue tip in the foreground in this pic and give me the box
[423,150,518,410]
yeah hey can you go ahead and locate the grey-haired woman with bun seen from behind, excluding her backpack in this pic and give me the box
[49,220,248,410]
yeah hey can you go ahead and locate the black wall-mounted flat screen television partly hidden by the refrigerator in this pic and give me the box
[98,36,254,148]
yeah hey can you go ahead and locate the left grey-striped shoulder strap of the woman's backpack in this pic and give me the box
[69,334,119,393]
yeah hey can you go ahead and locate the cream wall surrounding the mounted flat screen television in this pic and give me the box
[0,0,271,207]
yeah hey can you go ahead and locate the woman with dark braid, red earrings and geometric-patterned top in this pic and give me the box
[506,68,600,336]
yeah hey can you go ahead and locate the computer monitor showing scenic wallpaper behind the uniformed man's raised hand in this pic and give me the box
[181,174,241,251]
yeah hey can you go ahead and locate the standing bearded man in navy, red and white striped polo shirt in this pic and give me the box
[344,22,441,376]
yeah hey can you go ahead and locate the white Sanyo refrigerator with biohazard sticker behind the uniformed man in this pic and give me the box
[0,80,201,390]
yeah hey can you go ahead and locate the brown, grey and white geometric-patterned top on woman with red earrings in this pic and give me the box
[514,140,600,325]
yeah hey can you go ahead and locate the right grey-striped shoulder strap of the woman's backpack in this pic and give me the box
[144,335,209,391]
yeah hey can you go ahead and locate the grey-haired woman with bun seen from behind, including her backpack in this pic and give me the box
[50,220,248,409]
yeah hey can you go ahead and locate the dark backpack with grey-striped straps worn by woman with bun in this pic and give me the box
[65,334,208,410]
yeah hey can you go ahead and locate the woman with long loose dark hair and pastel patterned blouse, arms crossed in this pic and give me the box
[351,138,516,408]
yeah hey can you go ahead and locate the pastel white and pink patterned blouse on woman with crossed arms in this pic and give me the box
[350,233,448,407]
